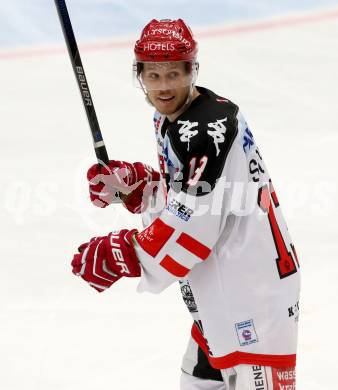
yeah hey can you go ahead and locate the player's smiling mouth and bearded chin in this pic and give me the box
[148,86,190,116]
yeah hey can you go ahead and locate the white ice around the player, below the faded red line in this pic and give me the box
[0,1,338,390]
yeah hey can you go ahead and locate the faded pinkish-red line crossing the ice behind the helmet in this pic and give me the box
[0,9,338,60]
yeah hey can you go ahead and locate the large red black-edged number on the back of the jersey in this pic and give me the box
[258,181,299,279]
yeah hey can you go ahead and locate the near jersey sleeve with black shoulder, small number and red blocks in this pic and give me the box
[135,103,247,293]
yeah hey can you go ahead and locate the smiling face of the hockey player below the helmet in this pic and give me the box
[141,62,191,115]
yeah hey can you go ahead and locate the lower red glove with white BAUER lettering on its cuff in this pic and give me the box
[72,229,141,292]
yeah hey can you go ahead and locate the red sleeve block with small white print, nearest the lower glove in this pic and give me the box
[135,218,175,257]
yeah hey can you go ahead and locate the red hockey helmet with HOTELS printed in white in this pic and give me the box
[134,19,197,62]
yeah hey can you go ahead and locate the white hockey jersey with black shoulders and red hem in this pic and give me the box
[135,87,300,369]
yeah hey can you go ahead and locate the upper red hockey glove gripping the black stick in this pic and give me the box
[87,160,160,214]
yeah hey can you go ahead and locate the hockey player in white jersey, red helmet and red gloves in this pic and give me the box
[72,19,299,390]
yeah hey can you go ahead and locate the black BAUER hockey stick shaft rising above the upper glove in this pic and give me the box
[55,0,109,166]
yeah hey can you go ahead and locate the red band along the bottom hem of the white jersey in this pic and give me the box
[191,324,296,370]
